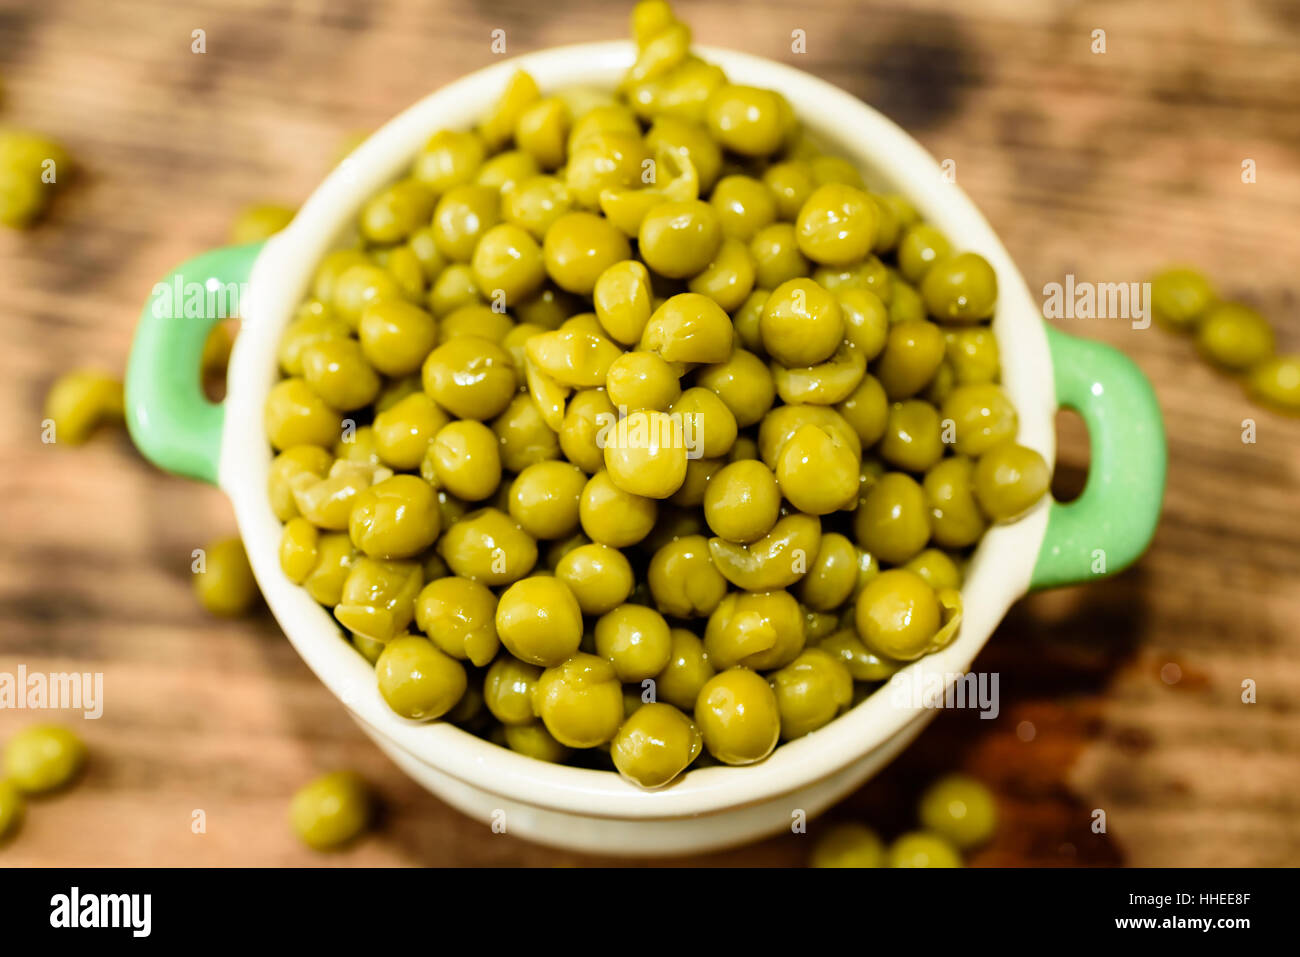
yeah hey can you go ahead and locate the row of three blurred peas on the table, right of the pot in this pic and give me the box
[1151,267,1300,415]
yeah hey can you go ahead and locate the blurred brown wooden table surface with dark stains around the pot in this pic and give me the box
[0,0,1300,865]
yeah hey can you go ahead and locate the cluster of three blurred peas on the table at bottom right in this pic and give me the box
[809,774,997,867]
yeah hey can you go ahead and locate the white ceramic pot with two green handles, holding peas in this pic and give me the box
[127,43,1165,854]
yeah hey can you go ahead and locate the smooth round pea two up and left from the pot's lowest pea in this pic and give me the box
[497,576,582,667]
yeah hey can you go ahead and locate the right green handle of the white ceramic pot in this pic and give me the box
[1030,326,1167,589]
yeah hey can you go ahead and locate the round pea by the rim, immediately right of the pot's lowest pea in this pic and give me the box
[696,668,781,765]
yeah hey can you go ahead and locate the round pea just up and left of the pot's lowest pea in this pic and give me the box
[533,653,623,748]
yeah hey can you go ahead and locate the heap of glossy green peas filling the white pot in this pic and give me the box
[265,0,1049,788]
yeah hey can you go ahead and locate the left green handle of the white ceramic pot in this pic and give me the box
[126,242,265,485]
